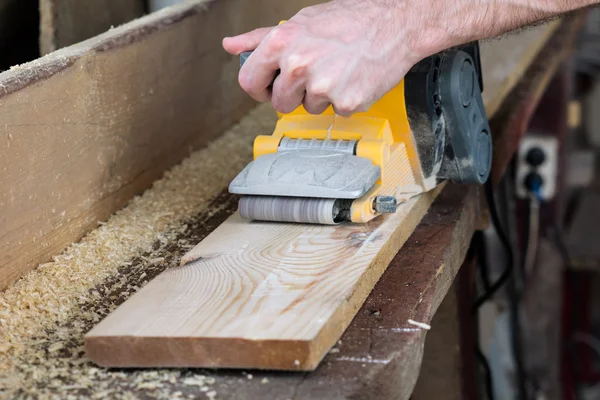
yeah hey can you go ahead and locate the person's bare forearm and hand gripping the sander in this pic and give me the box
[223,0,600,116]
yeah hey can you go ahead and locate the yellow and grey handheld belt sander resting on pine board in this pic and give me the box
[229,42,492,225]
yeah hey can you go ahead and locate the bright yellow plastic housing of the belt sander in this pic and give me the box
[254,81,425,223]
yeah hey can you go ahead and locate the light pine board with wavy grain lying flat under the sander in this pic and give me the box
[86,19,556,370]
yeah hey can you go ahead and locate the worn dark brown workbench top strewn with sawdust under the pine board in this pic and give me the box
[0,7,578,399]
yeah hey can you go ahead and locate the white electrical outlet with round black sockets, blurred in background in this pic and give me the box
[516,134,558,201]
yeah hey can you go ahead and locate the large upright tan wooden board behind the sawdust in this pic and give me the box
[0,0,324,290]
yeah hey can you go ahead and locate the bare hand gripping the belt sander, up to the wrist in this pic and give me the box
[223,0,427,116]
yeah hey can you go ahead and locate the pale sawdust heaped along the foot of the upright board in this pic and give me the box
[0,105,276,399]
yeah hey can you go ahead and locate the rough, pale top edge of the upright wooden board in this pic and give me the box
[0,0,214,97]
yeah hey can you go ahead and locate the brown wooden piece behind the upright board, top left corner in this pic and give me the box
[39,0,145,55]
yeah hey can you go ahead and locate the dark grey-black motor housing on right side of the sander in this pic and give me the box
[404,42,492,184]
